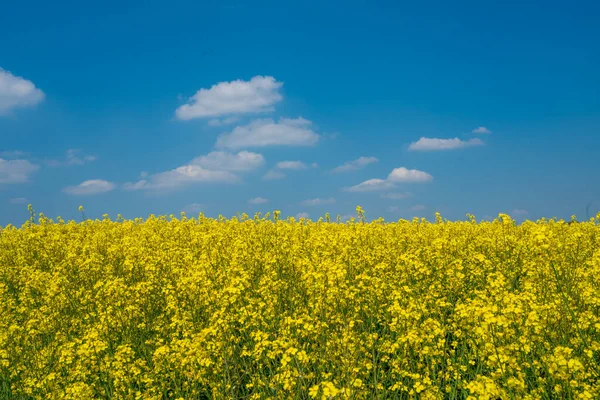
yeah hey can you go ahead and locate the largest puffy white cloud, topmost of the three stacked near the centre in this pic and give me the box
[175,76,283,120]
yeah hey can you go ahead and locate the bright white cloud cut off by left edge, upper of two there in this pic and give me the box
[0,68,45,115]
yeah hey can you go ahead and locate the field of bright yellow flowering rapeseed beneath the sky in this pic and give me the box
[0,208,600,400]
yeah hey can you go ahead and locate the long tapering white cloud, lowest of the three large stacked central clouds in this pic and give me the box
[123,164,239,190]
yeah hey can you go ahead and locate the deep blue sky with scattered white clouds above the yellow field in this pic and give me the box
[0,1,600,225]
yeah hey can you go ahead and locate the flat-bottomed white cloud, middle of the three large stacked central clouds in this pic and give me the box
[215,117,320,149]
